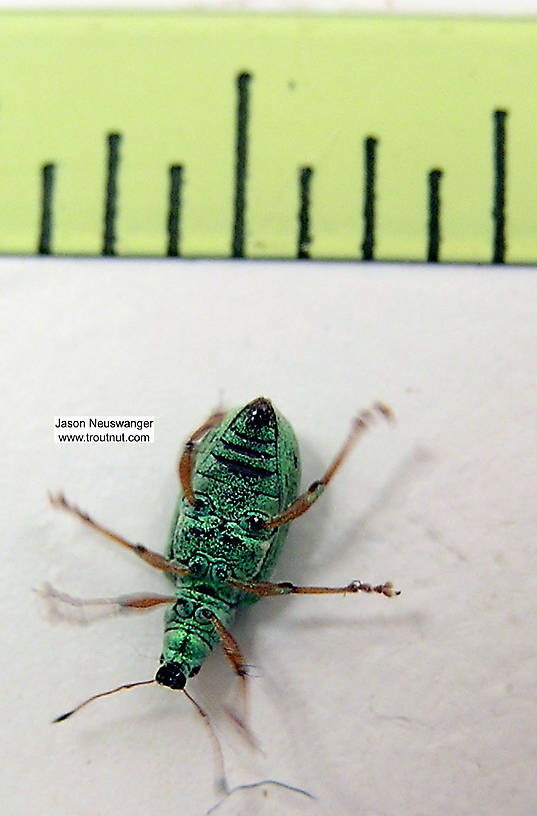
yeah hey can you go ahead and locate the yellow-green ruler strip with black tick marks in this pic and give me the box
[0,12,537,264]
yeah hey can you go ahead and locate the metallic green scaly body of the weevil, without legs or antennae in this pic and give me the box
[156,398,300,687]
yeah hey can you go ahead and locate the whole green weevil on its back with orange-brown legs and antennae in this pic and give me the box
[45,397,398,784]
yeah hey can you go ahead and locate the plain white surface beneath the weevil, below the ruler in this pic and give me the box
[0,259,537,816]
